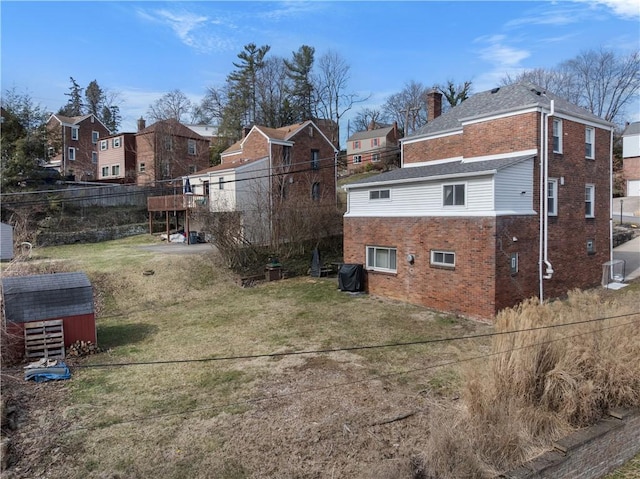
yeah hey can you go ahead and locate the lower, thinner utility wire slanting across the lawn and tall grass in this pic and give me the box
[69,313,637,431]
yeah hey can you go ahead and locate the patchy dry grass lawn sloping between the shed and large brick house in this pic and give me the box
[3,235,638,479]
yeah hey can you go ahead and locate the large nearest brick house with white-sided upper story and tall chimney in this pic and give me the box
[344,84,613,318]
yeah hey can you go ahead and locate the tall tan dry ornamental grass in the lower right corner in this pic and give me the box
[423,290,640,479]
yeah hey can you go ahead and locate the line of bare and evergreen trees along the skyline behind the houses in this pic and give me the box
[0,43,640,191]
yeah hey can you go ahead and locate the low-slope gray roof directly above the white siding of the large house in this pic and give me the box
[345,155,535,188]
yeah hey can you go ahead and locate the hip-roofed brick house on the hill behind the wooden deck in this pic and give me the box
[135,118,209,186]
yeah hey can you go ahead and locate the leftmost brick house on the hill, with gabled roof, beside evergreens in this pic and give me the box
[46,114,111,181]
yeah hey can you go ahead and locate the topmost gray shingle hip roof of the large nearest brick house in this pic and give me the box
[405,83,611,140]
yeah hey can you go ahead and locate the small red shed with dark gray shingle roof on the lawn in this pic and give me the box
[1,273,97,358]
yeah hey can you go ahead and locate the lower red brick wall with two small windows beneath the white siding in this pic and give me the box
[344,218,496,318]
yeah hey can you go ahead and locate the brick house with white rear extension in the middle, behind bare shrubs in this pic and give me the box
[188,121,338,244]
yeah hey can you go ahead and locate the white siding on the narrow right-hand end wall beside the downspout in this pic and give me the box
[495,160,533,213]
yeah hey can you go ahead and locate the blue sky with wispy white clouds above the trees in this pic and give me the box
[0,0,640,141]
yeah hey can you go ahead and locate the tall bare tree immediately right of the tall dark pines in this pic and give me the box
[315,50,371,145]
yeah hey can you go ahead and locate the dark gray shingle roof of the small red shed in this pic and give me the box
[2,273,94,323]
